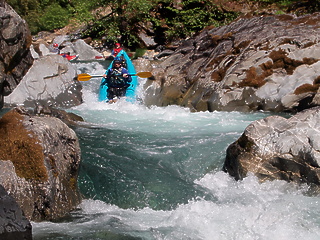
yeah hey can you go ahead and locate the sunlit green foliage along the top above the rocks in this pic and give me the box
[7,0,320,46]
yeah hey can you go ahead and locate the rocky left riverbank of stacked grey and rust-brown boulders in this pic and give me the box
[0,0,81,240]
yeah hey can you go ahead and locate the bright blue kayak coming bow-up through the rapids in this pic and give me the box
[99,50,138,102]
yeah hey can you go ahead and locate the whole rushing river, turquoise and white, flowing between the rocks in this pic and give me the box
[18,60,320,240]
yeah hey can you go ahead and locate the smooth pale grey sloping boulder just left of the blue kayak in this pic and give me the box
[5,54,82,108]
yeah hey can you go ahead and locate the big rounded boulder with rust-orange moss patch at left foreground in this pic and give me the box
[0,108,81,221]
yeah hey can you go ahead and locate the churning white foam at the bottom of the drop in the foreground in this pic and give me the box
[34,171,320,240]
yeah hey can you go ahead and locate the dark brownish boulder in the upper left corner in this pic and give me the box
[0,0,33,108]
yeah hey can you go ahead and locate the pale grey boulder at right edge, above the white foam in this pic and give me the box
[223,107,320,186]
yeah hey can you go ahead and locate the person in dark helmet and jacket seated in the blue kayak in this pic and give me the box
[102,59,132,103]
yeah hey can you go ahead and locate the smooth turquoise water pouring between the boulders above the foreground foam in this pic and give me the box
[77,106,262,210]
